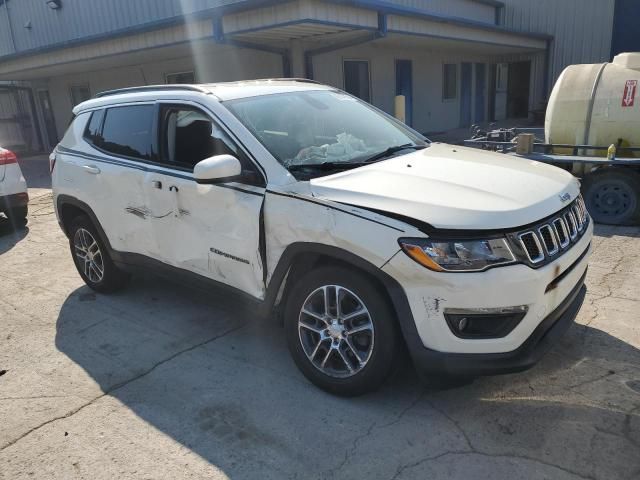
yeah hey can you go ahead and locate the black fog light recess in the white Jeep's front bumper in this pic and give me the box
[444,305,529,339]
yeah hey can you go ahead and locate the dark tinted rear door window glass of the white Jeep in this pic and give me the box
[97,105,155,160]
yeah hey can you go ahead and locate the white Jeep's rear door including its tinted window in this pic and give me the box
[73,103,157,255]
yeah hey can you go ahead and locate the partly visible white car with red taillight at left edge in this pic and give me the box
[0,147,29,227]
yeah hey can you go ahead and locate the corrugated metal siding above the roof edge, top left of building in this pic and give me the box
[0,0,245,55]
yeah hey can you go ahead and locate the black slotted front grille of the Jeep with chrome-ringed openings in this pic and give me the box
[508,196,589,267]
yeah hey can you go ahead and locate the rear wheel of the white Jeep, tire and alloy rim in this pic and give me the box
[69,215,129,293]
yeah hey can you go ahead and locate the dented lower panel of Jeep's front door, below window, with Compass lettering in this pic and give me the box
[145,173,264,298]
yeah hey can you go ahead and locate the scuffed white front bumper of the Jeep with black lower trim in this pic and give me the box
[382,221,593,376]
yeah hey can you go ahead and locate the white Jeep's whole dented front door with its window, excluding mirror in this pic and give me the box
[145,103,265,298]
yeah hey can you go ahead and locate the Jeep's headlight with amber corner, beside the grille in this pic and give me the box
[399,238,516,272]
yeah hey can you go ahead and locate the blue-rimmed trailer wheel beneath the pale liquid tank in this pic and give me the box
[582,168,640,225]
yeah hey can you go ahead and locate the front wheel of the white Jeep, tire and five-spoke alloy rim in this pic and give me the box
[284,267,400,396]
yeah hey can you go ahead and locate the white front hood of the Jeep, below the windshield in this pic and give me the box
[310,143,580,230]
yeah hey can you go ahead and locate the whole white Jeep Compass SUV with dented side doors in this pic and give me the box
[51,80,592,395]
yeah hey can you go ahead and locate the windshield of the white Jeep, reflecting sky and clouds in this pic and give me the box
[224,91,425,177]
